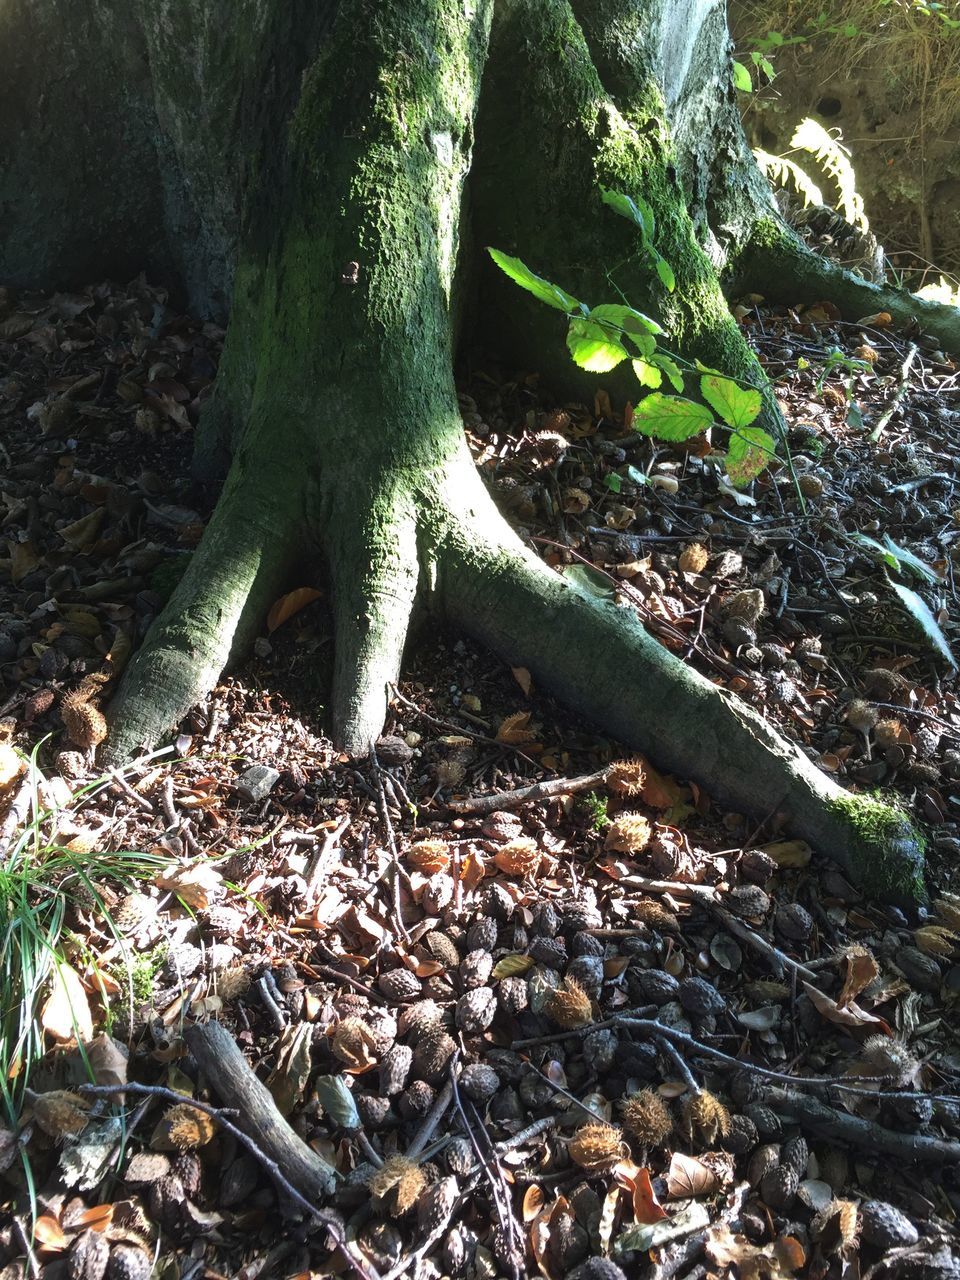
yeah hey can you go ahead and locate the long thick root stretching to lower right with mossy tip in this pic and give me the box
[443,465,924,902]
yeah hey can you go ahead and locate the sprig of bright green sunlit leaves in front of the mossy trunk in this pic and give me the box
[488,188,776,488]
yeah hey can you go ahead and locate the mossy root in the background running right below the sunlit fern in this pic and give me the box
[727,218,960,353]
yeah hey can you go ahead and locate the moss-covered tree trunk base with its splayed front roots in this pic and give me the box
[0,0,957,899]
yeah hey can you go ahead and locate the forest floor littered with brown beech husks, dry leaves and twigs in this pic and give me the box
[0,282,960,1280]
